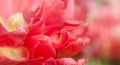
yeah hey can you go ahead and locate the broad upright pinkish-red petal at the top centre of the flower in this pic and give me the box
[32,0,64,26]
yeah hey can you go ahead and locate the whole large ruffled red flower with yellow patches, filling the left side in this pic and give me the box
[0,0,90,65]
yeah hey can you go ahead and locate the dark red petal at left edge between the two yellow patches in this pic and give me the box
[0,31,26,47]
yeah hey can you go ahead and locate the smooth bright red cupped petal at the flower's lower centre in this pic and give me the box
[24,35,56,59]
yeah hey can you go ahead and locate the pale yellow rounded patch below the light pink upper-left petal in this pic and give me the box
[8,13,26,31]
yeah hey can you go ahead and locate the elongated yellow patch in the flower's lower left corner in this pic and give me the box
[0,47,27,61]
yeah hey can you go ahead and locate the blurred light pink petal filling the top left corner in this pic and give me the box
[0,0,32,21]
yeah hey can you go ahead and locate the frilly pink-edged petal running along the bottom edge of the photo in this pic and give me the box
[42,58,86,65]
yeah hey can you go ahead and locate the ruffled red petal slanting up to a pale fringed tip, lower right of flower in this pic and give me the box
[57,38,89,57]
